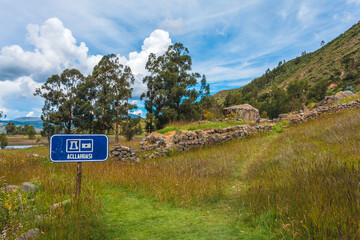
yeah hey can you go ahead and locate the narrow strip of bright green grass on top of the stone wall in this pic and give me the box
[157,121,248,134]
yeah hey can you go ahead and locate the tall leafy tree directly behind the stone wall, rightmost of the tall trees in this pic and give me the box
[142,43,206,129]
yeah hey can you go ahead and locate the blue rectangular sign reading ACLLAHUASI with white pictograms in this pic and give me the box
[50,134,109,162]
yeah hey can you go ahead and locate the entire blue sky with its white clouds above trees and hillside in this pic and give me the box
[0,0,360,119]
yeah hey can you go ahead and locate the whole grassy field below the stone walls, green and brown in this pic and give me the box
[0,109,360,239]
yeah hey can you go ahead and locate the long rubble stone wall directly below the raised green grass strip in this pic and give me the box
[140,124,272,159]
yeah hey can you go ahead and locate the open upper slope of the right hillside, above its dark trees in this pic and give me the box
[212,22,360,108]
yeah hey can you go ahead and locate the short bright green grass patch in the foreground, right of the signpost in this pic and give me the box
[102,186,243,239]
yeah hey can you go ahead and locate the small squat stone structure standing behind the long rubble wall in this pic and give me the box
[223,104,260,122]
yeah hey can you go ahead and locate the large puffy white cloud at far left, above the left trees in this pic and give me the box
[0,18,101,81]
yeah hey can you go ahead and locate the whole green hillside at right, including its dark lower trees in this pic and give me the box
[213,22,360,117]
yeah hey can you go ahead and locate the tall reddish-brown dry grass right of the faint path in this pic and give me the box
[238,109,360,239]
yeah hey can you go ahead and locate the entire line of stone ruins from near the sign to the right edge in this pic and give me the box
[111,91,360,162]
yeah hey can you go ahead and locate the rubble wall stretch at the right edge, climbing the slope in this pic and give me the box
[290,99,360,124]
